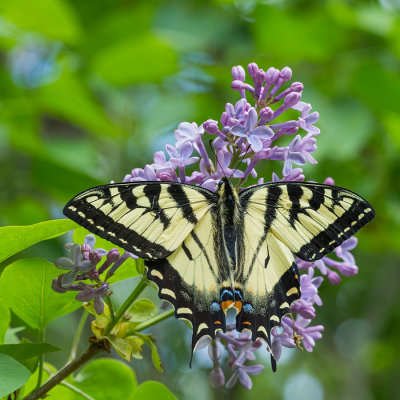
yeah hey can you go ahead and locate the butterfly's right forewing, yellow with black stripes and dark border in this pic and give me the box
[240,182,375,261]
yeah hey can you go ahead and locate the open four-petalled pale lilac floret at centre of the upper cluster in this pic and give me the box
[231,107,274,153]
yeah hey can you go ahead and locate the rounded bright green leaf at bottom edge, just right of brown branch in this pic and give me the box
[72,358,137,400]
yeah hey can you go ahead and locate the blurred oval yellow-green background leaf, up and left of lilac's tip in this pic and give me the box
[93,34,177,85]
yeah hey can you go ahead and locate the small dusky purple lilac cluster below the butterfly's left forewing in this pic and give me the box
[51,234,137,315]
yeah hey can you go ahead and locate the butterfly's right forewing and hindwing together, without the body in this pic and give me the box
[236,182,375,343]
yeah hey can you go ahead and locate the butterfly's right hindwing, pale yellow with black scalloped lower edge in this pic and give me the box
[235,203,300,346]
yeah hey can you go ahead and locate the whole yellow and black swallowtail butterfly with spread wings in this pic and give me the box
[64,177,375,360]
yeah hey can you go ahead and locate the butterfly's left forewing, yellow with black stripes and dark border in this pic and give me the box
[64,181,216,259]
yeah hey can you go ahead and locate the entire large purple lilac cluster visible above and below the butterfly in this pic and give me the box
[124,63,357,389]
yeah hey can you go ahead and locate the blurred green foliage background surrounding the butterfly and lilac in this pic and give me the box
[0,0,400,400]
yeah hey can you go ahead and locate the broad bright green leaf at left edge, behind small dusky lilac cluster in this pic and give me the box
[0,258,81,330]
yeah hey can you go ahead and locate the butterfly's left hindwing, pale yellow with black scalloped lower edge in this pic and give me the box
[145,208,228,354]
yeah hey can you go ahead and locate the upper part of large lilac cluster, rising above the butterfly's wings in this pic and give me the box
[124,63,320,190]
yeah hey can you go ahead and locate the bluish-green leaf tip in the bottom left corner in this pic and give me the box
[0,354,30,397]
